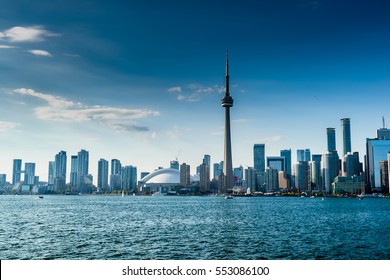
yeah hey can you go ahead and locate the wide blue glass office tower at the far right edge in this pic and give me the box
[366,138,390,191]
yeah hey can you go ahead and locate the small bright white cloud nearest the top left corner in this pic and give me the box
[0,26,58,42]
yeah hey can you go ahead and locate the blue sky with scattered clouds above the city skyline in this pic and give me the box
[0,0,390,183]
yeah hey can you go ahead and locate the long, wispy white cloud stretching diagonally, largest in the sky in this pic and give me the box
[13,88,160,132]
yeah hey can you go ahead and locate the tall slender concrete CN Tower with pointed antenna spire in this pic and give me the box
[221,51,233,193]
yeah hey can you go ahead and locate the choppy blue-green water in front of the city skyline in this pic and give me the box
[0,195,390,260]
